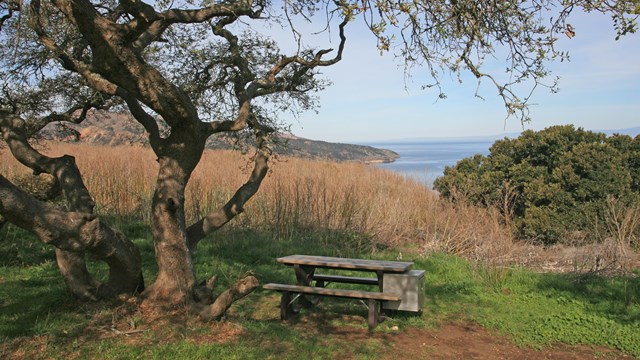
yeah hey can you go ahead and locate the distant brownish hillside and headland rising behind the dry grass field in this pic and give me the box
[39,113,399,163]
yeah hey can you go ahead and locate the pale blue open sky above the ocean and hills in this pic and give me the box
[276,9,640,143]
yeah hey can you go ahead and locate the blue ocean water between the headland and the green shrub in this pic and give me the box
[367,139,494,188]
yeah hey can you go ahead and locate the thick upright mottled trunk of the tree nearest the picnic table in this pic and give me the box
[143,128,264,312]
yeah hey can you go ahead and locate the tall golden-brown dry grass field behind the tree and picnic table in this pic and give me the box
[0,144,513,258]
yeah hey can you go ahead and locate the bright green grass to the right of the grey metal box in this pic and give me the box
[418,255,640,357]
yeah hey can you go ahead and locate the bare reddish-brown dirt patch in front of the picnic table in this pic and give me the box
[266,311,635,360]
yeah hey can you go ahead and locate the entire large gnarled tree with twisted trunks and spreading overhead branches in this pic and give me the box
[0,0,639,318]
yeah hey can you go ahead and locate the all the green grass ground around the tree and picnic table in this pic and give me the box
[0,222,640,359]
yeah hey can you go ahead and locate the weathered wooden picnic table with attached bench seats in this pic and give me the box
[263,255,413,329]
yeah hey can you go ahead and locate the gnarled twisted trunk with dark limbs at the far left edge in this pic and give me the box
[0,112,144,299]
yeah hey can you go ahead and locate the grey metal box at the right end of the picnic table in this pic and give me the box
[382,270,425,312]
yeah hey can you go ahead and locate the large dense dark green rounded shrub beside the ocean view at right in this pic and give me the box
[434,126,640,244]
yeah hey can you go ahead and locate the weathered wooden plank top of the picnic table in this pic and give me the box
[277,255,413,273]
